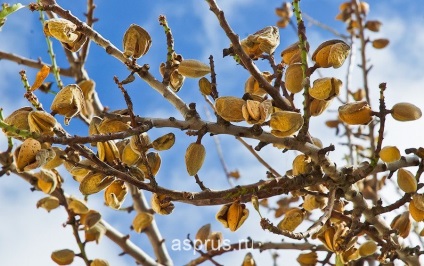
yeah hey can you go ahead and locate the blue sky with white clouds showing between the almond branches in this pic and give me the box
[0,0,424,266]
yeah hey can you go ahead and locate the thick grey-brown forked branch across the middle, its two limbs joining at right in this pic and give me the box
[0,116,419,205]
